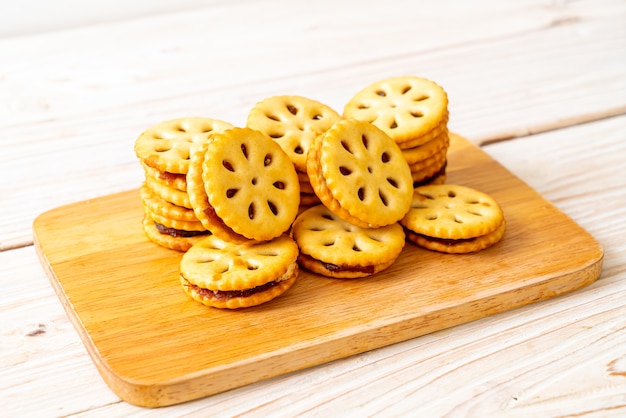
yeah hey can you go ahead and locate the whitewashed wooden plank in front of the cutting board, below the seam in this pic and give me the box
[0,118,626,418]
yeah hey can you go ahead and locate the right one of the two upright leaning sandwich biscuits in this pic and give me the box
[307,120,413,228]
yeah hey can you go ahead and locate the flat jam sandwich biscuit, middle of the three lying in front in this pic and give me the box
[291,205,405,278]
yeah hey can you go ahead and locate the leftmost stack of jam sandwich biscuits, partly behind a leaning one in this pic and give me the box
[135,117,232,251]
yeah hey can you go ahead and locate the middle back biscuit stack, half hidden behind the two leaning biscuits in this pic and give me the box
[247,96,341,208]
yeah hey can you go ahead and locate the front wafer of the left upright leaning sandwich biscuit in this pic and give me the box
[200,128,300,241]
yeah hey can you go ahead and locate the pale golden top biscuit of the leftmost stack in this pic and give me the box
[135,117,232,174]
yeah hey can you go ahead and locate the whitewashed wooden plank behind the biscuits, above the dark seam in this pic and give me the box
[0,0,626,250]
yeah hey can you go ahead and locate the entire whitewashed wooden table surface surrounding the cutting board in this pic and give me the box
[0,0,626,417]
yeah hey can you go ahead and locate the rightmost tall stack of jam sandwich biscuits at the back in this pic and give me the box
[343,76,449,187]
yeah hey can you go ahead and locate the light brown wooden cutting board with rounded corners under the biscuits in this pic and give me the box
[33,136,603,407]
